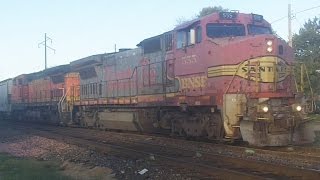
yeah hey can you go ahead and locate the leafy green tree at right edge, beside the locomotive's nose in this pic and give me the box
[293,17,320,94]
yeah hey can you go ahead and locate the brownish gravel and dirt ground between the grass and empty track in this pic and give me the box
[0,126,115,180]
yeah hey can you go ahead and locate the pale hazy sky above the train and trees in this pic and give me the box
[0,0,320,80]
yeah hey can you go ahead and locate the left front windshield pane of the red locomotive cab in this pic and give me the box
[207,23,246,38]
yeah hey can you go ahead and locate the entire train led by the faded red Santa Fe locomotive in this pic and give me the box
[0,12,313,146]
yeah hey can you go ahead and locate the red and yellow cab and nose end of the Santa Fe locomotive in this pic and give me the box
[174,12,312,146]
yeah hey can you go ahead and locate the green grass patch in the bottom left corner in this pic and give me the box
[0,154,71,180]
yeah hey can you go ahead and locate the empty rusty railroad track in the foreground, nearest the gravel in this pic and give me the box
[8,121,320,179]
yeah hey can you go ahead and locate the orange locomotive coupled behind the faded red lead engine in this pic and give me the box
[10,65,79,124]
